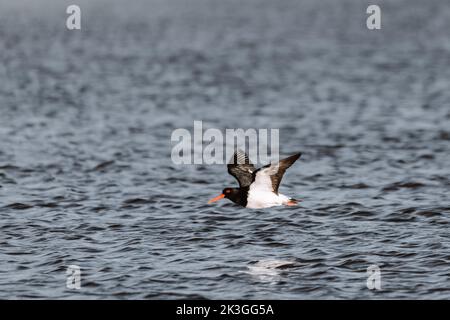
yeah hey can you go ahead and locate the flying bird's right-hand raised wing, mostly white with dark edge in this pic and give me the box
[252,153,302,194]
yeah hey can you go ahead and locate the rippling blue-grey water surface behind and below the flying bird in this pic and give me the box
[0,0,450,299]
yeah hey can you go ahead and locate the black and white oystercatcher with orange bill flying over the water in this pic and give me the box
[208,150,301,209]
